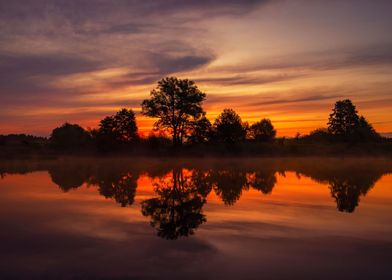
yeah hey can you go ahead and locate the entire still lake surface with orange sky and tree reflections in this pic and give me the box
[0,158,392,280]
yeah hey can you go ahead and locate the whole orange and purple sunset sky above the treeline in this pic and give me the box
[0,0,392,136]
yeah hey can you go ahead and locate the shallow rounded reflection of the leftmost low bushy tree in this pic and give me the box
[48,164,91,192]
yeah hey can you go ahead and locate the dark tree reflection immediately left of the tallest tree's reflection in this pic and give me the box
[89,170,138,207]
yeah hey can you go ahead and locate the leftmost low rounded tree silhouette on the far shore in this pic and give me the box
[49,123,91,150]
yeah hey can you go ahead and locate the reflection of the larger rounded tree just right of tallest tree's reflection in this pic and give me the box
[211,170,247,205]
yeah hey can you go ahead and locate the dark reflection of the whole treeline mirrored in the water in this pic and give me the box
[35,160,391,239]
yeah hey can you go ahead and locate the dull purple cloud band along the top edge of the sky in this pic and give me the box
[0,0,273,24]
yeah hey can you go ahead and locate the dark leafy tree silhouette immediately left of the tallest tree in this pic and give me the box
[96,108,138,149]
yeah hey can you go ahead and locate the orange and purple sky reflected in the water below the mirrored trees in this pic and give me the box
[0,172,392,279]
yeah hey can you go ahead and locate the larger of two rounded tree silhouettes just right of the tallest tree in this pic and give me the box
[214,109,246,144]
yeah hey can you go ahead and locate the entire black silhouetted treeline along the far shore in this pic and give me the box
[0,77,392,158]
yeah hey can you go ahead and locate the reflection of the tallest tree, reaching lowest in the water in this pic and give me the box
[142,169,208,239]
